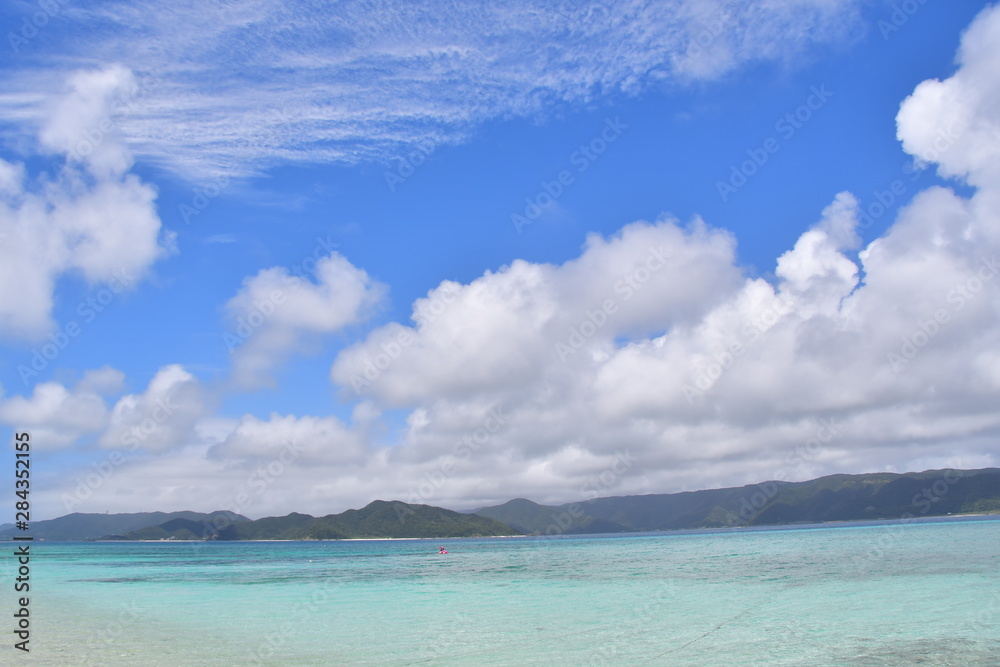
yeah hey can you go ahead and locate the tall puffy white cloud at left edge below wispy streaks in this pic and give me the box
[0,66,172,340]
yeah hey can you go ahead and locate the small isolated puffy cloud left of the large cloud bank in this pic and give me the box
[225,251,385,388]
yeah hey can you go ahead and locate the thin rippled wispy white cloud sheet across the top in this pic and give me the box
[0,0,860,178]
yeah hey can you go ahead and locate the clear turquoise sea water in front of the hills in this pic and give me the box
[7,517,1000,666]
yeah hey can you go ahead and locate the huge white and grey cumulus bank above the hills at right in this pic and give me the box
[19,2,1000,514]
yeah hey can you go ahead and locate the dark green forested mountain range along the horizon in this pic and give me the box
[0,468,1000,541]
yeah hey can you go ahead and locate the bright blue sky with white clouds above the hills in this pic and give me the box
[0,0,1000,520]
